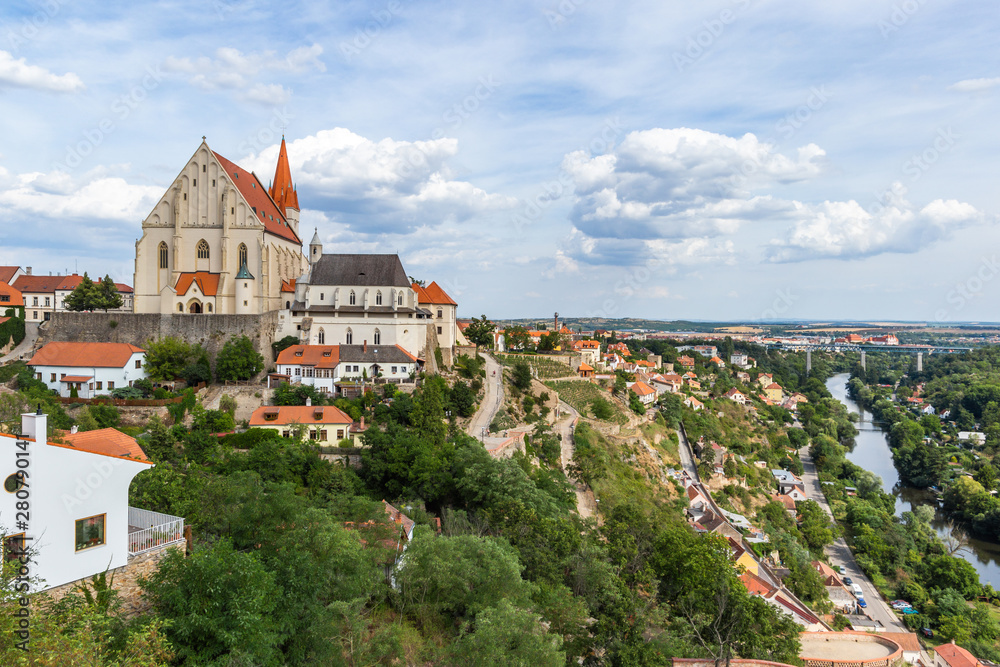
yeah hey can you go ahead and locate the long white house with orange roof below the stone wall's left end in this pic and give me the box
[28,342,146,398]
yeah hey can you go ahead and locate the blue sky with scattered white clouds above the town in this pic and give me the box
[0,0,1000,324]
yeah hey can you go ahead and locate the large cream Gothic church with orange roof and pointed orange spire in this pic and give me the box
[134,137,307,315]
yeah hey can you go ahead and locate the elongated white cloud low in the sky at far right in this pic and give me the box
[768,184,986,262]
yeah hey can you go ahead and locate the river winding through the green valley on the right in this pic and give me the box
[826,373,1000,588]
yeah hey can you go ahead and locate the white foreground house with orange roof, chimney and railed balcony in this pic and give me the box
[0,414,184,592]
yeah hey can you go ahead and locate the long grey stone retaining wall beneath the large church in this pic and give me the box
[38,311,278,364]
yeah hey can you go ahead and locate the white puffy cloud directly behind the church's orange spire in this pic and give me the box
[240,128,517,234]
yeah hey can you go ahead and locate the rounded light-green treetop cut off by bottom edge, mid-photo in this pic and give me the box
[452,600,566,667]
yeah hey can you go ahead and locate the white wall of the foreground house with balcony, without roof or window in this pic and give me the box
[0,414,152,591]
